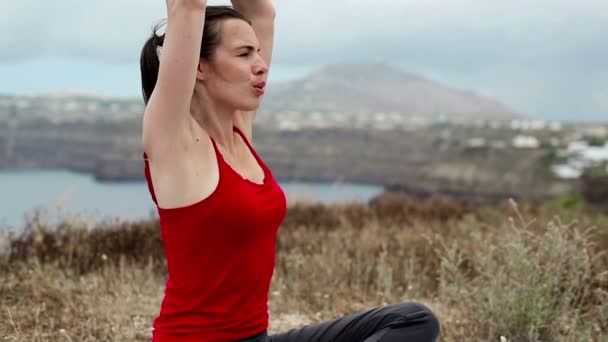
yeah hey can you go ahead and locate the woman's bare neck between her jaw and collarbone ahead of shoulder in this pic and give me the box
[190,94,235,151]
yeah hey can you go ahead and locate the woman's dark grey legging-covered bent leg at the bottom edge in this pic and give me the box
[244,303,439,342]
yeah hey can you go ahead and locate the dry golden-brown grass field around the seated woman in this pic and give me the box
[0,194,608,341]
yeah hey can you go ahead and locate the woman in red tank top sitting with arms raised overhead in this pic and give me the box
[141,0,439,342]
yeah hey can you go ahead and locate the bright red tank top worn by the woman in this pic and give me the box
[144,127,286,342]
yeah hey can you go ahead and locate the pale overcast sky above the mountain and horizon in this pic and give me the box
[0,0,608,121]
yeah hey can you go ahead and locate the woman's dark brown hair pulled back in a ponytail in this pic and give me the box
[139,6,251,104]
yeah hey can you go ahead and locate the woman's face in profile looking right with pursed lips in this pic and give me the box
[199,19,268,111]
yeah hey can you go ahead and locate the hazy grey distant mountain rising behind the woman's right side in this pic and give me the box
[261,64,522,119]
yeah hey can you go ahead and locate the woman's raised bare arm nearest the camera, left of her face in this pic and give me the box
[142,0,207,158]
